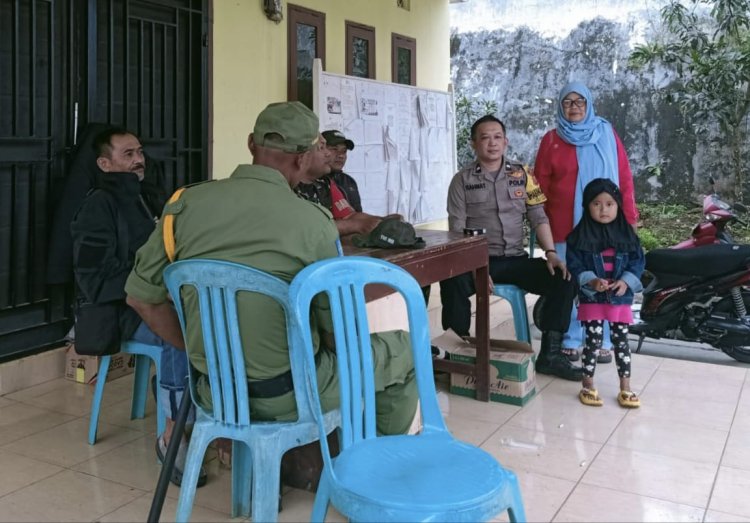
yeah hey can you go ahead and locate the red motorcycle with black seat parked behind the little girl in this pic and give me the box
[534,179,750,363]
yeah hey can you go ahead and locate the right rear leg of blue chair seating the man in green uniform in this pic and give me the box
[251,440,282,521]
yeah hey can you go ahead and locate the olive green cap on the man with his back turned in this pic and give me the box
[253,102,320,153]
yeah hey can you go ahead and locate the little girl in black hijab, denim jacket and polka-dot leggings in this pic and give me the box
[566,178,645,408]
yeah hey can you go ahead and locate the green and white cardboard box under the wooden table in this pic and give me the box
[432,331,536,406]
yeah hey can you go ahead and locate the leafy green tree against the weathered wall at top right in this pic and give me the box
[629,0,750,200]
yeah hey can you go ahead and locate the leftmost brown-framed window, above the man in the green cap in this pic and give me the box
[287,4,326,109]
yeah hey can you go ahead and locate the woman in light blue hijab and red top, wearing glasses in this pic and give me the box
[534,82,638,363]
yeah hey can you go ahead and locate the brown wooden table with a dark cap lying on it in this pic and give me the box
[342,229,490,401]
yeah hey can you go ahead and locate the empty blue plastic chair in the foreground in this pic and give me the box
[289,256,526,521]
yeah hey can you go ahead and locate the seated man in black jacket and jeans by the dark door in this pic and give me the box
[70,128,206,486]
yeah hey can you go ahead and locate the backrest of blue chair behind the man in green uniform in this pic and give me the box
[164,259,312,426]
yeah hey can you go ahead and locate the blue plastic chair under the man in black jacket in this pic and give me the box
[89,341,166,445]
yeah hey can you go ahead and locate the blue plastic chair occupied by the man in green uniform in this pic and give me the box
[164,259,340,522]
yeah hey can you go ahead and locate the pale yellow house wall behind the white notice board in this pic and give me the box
[210,0,450,178]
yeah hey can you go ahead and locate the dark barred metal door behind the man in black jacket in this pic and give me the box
[0,0,209,360]
